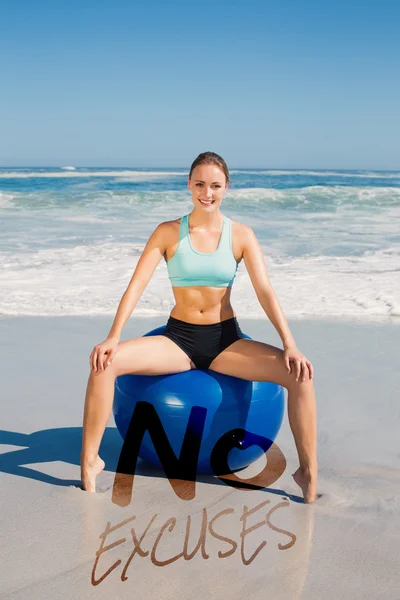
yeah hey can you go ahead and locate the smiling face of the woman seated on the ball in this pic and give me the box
[188,165,228,212]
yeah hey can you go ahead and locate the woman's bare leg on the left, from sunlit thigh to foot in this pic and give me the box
[81,336,193,492]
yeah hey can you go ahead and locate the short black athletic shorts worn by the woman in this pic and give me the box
[161,317,244,369]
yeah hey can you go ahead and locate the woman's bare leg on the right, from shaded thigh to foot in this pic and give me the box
[209,339,318,502]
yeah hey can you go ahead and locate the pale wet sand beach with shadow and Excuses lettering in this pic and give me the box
[0,315,400,600]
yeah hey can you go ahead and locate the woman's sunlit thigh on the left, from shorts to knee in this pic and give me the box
[112,335,194,376]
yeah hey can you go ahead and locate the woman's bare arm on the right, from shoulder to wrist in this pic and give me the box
[242,225,296,349]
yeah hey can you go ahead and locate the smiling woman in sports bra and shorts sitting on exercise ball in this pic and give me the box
[81,152,318,502]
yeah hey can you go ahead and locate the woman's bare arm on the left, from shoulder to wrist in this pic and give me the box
[108,223,170,340]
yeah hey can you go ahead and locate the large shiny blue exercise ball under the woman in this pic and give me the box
[113,326,284,473]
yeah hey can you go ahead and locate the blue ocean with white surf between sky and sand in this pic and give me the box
[0,166,400,322]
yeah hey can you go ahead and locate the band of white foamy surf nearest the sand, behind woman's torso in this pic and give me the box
[0,243,400,320]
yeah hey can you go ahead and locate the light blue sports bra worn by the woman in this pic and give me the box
[167,215,238,287]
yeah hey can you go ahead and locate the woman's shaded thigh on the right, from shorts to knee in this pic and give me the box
[209,339,296,389]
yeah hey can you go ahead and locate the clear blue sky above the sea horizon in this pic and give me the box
[0,0,400,169]
